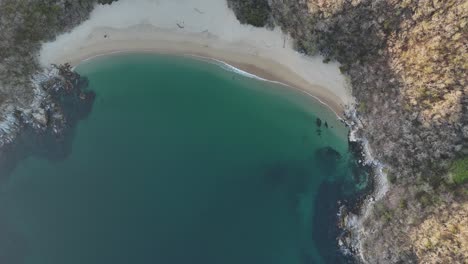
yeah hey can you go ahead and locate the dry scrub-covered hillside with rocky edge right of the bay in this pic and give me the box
[228,0,468,263]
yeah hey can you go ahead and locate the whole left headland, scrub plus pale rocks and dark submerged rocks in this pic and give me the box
[0,0,112,180]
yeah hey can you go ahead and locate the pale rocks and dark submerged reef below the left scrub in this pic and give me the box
[0,65,95,182]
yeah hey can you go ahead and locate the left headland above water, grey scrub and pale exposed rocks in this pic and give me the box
[0,0,117,147]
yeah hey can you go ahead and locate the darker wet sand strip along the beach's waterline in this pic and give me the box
[44,33,353,119]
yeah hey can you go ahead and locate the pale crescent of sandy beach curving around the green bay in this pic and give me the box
[39,0,353,113]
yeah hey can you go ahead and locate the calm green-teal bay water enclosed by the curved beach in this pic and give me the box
[0,54,366,264]
